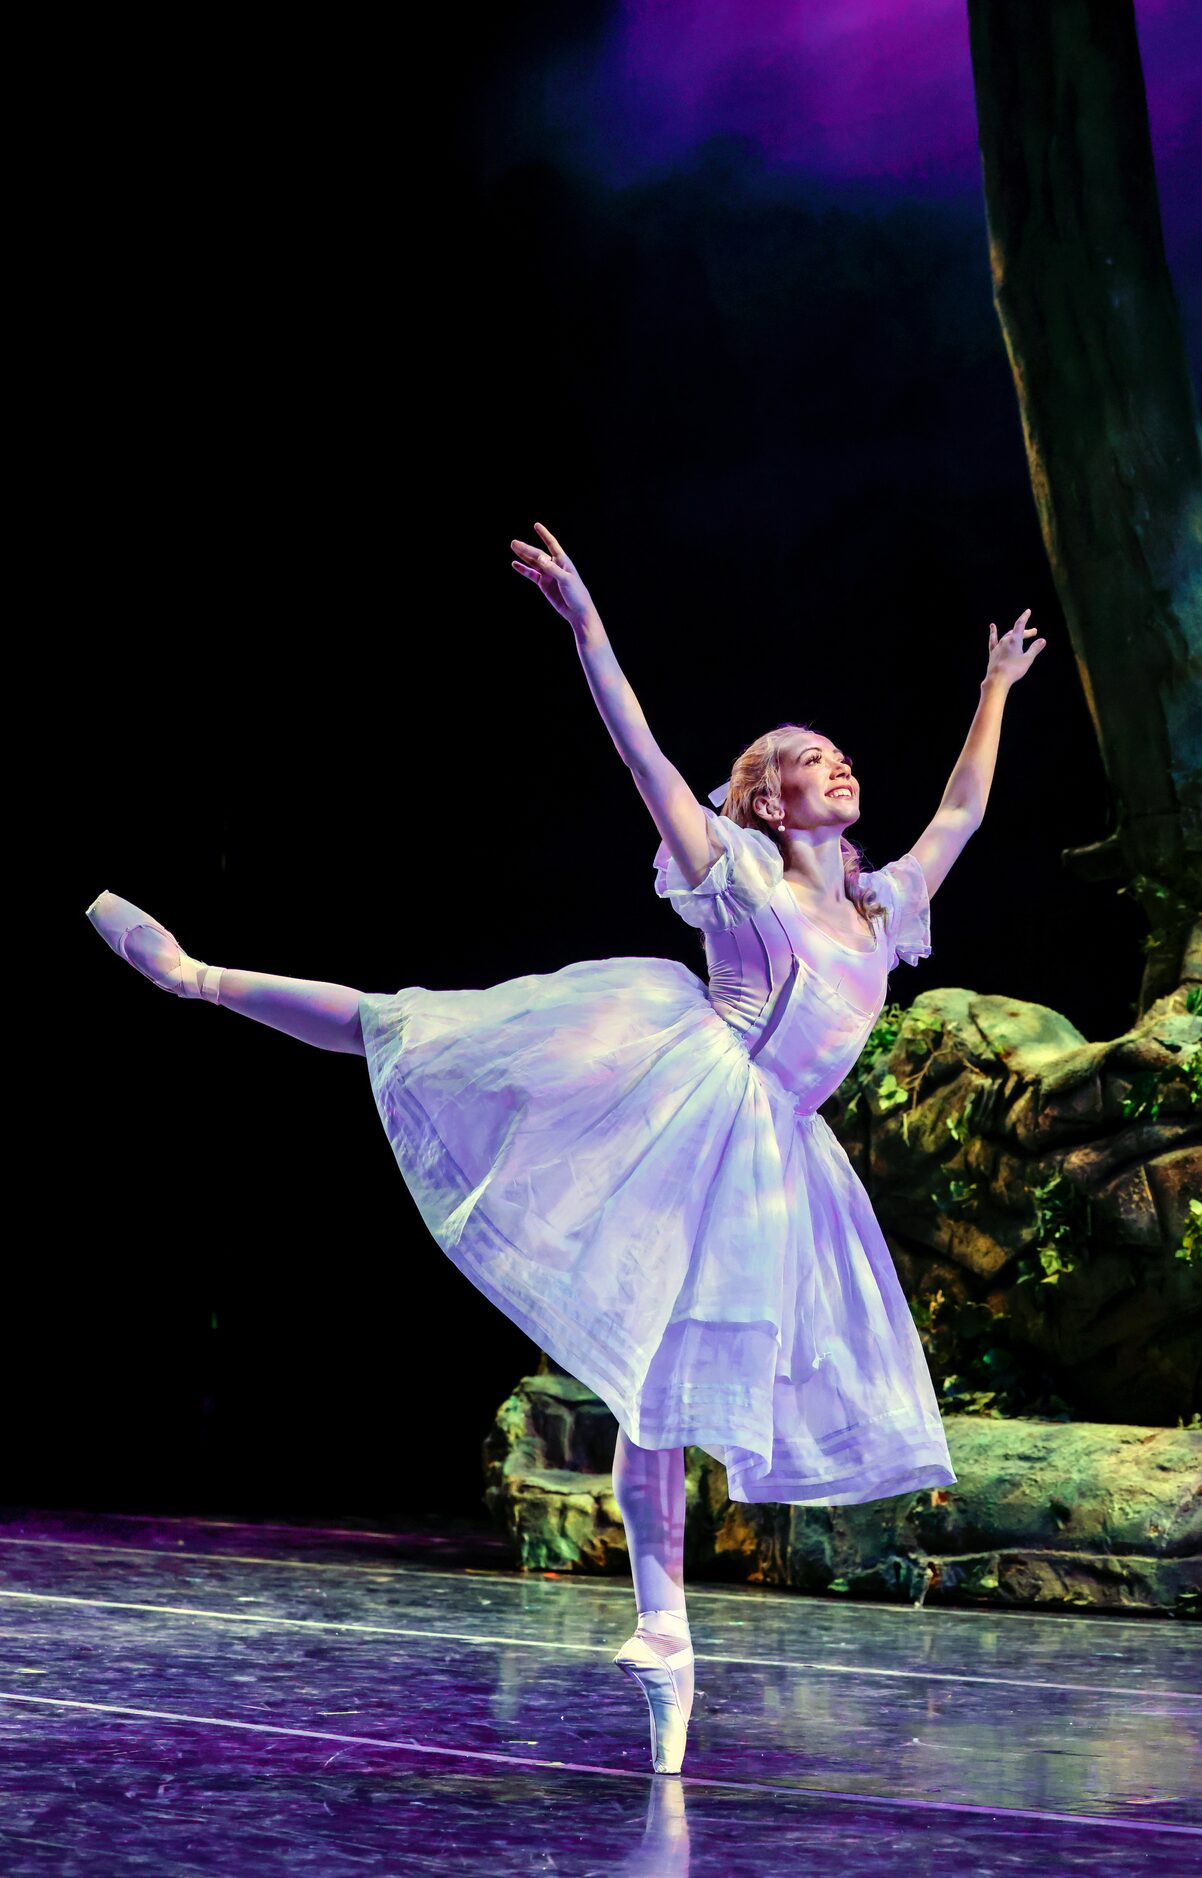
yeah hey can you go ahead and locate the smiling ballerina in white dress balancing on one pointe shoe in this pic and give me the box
[86,522,1044,1773]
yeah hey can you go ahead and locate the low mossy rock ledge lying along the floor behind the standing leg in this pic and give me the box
[485,1365,1202,1617]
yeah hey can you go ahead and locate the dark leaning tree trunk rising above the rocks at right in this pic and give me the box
[969,0,1202,1014]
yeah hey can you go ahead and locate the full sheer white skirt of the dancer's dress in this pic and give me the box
[361,958,956,1504]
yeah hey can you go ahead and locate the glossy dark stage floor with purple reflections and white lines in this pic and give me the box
[0,1508,1202,1878]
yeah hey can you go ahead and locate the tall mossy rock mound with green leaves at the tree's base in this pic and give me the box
[824,984,1202,1425]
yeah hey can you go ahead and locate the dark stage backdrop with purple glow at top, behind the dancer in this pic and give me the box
[35,4,1202,1517]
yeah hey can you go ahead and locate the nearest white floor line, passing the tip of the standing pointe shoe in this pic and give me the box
[0,1690,1202,1839]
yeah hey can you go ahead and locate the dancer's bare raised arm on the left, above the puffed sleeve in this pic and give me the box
[509,522,721,886]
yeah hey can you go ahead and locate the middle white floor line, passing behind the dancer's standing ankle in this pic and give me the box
[0,1591,1202,1713]
